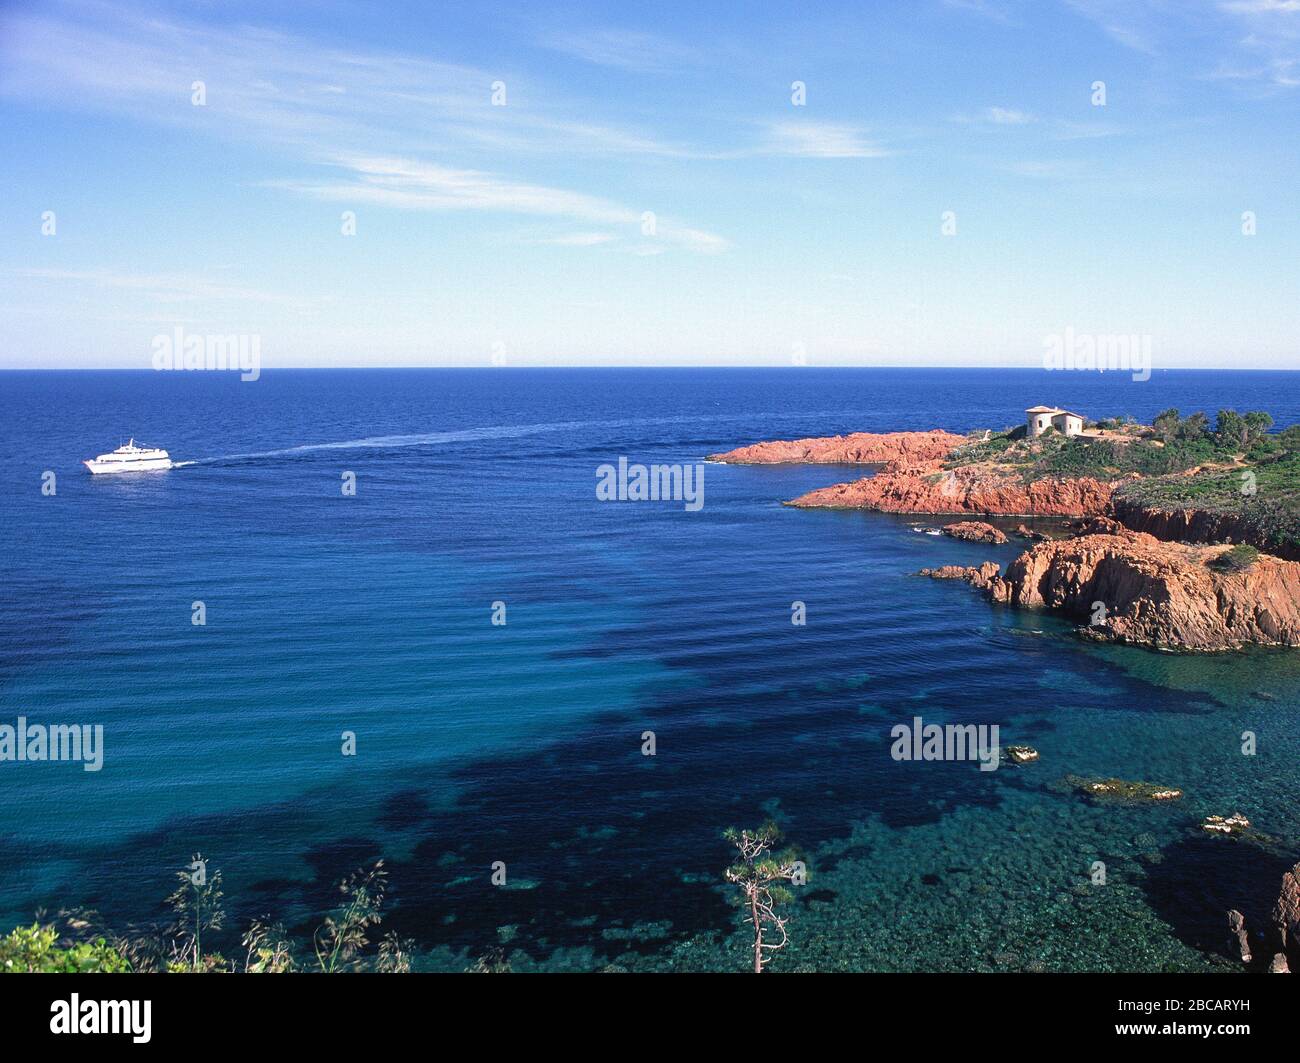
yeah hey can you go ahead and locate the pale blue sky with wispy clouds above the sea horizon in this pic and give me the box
[0,0,1300,368]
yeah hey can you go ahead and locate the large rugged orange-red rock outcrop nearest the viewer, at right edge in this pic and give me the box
[988,532,1300,651]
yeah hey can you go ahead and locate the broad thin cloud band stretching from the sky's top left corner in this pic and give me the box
[0,3,712,157]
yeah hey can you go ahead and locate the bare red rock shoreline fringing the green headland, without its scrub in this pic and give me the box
[710,430,1300,652]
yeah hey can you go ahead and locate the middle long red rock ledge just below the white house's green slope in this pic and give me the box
[789,468,1114,517]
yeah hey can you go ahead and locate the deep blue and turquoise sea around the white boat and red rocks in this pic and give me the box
[0,368,1300,971]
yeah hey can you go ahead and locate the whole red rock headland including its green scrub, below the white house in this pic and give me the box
[714,411,1300,651]
